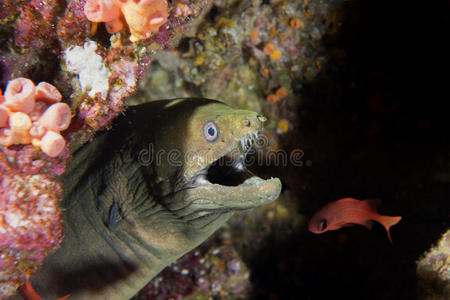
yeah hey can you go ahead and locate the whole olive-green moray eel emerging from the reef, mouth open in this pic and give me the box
[31,99,281,299]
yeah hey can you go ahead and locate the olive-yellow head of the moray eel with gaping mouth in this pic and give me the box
[132,99,281,243]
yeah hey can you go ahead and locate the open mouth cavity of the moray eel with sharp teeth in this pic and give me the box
[192,131,264,186]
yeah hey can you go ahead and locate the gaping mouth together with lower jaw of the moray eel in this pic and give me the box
[189,131,281,210]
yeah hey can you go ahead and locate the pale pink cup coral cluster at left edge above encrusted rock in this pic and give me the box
[0,77,72,157]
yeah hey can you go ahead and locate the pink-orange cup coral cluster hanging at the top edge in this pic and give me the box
[84,0,168,42]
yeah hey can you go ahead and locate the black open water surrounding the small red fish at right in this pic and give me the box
[250,1,450,299]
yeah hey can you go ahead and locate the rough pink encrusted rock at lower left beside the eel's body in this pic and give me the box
[0,172,62,299]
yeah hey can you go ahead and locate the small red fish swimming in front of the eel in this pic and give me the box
[308,198,402,244]
